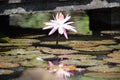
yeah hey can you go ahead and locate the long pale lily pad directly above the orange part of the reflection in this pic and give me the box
[61,60,105,66]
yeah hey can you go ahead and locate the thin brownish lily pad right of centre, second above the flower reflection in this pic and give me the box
[58,54,96,60]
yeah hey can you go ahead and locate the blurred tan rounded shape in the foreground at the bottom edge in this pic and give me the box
[17,68,55,80]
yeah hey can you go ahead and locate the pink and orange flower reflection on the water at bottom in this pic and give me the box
[48,61,85,80]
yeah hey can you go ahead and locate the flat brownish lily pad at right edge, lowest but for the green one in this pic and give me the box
[85,72,120,78]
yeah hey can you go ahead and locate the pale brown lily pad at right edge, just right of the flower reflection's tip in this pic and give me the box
[87,65,120,72]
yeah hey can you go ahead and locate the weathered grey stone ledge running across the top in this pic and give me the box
[0,0,120,15]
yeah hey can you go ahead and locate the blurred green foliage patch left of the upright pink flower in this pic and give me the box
[18,13,50,28]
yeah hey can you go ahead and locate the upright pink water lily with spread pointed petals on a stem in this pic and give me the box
[43,13,77,39]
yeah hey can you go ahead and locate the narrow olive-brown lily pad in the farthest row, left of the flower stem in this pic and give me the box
[10,39,40,44]
